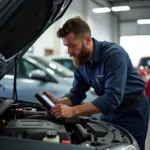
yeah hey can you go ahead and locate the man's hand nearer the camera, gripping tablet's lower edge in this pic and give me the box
[50,104,76,119]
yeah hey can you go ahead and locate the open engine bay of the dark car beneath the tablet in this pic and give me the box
[0,99,138,147]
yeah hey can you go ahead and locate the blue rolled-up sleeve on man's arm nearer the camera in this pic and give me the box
[92,53,127,115]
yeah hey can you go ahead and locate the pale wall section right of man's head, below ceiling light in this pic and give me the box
[87,2,118,42]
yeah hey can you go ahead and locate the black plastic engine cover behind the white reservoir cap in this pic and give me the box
[4,119,70,140]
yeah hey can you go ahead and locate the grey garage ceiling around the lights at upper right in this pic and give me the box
[93,0,150,22]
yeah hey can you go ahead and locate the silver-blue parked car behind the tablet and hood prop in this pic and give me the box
[0,55,95,102]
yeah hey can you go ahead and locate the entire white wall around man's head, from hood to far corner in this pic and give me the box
[33,0,118,56]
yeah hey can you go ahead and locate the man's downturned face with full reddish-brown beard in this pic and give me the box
[63,33,89,67]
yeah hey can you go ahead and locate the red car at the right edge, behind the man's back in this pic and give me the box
[137,57,150,99]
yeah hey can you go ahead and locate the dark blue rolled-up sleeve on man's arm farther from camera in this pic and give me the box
[64,69,90,105]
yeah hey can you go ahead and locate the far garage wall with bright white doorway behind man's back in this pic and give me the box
[120,3,150,67]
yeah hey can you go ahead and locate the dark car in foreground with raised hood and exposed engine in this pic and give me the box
[0,0,138,150]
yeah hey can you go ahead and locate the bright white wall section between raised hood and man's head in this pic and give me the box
[33,0,87,56]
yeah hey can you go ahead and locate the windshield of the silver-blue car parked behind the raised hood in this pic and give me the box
[30,56,74,77]
